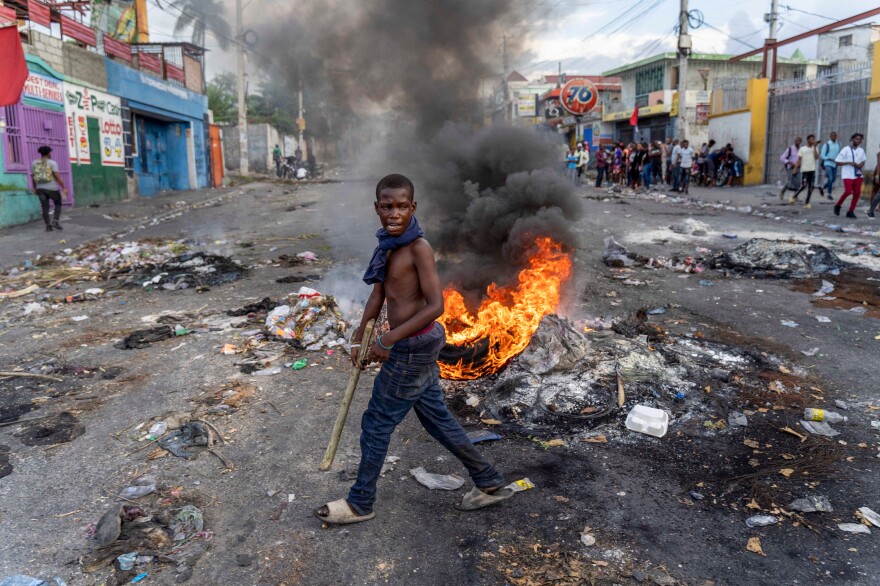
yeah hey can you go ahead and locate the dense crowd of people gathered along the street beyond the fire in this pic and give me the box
[566,138,743,193]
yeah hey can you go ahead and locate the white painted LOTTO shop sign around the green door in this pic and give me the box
[64,82,125,167]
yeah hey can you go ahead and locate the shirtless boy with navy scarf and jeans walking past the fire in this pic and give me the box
[315,175,513,524]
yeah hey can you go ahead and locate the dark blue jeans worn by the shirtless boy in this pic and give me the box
[348,323,504,515]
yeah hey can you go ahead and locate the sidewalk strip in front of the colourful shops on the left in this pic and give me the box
[0,183,259,268]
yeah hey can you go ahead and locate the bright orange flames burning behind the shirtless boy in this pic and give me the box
[438,238,571,380]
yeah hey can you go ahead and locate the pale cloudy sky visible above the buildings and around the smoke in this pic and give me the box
[148,0,880,79]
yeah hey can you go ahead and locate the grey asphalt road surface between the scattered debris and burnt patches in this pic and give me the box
[0,181,880,585]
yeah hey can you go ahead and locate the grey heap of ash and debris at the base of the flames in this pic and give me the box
[449,310,776,434]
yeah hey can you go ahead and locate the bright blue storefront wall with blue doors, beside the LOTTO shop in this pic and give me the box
[105,59,208,195]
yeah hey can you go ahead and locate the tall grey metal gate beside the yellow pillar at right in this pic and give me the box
[764,64,871,184]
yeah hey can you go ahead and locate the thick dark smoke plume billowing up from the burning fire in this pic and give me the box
[251,0,581,265]
